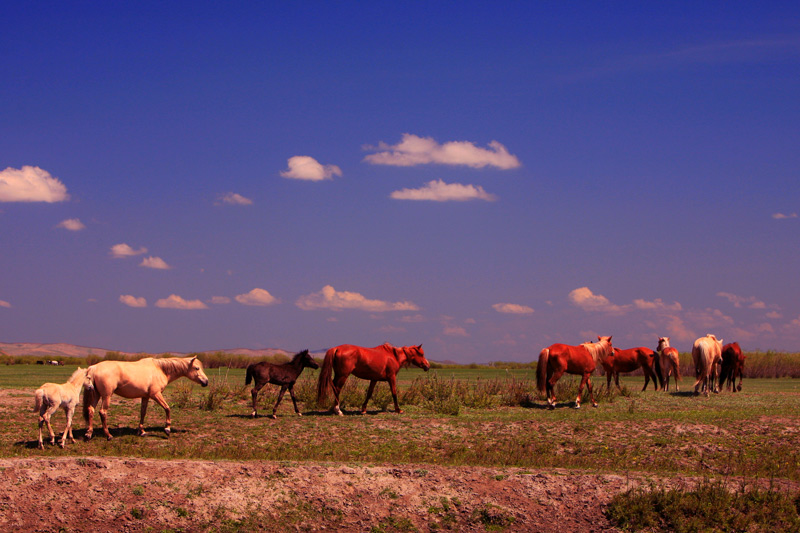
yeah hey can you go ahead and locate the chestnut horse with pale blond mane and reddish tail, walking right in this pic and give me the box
[536,336,614,409]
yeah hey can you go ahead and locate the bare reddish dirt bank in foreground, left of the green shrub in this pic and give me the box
[0,457,692,532]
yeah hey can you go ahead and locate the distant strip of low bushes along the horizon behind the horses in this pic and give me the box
[0,350,800,378]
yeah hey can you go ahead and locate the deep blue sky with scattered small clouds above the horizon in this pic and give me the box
[0,2,800,362]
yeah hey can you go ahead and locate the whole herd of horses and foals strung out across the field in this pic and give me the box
[34,335,744,448]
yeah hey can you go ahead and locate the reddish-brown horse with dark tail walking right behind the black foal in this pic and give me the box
[317,343,431,416]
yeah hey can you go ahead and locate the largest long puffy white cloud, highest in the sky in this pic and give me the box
[364,133,520,169]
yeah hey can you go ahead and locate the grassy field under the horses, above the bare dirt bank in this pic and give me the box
[0,365,800,481]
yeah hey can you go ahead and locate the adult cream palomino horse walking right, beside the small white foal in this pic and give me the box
[83,357,208,440]
